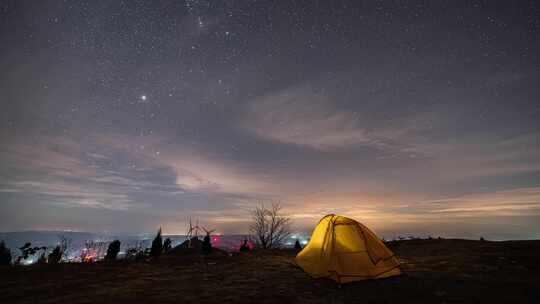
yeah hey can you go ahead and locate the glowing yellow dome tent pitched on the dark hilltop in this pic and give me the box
[296,214,401,283]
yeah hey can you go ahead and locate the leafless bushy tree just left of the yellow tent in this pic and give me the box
[251,202,291,249]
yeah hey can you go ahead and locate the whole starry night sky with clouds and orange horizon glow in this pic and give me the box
[0,0,540,239]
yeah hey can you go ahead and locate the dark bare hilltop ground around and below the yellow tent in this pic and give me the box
[0,239,540,303]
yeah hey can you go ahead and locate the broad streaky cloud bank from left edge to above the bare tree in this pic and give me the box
[0,135,276,217]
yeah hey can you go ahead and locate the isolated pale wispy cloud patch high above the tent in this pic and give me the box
[242,86,395,151]
